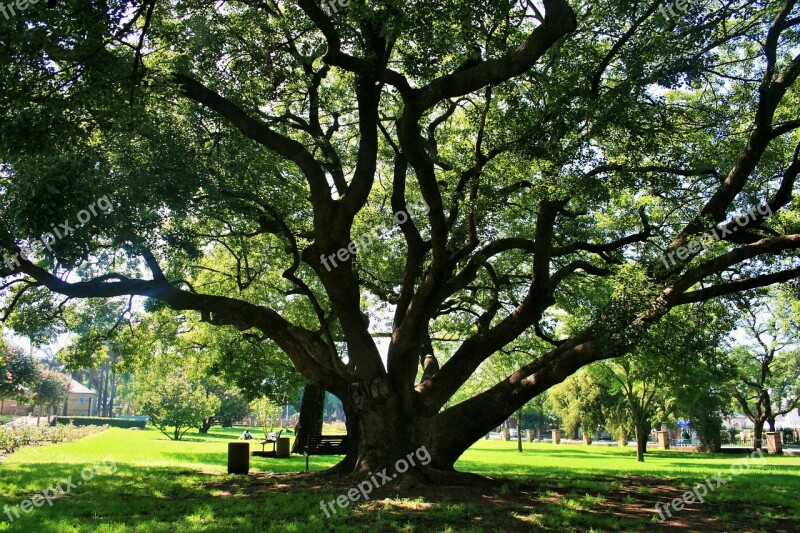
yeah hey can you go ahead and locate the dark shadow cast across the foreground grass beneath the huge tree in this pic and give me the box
[0,453,800,533]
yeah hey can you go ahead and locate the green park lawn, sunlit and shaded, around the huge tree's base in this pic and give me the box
[0,428,800,532]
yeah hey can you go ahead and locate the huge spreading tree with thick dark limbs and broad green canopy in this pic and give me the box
[0,0,800,480]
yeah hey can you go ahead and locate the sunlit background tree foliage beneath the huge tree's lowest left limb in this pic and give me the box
[59,302,301,433]
